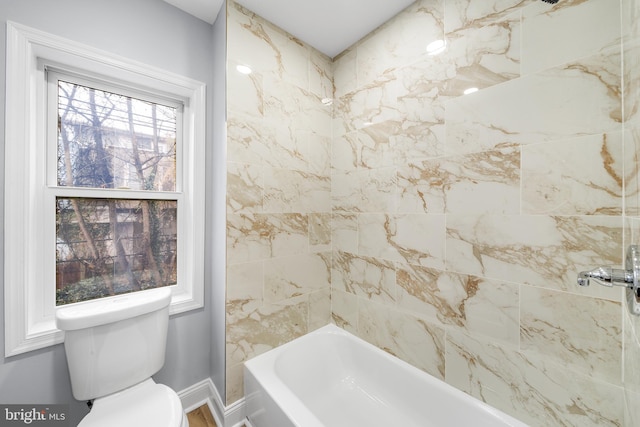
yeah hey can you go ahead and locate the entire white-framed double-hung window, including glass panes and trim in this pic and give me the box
[5,23,205,356]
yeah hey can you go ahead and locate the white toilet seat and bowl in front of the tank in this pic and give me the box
[78,378,189,427]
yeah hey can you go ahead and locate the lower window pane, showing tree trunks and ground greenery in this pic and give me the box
[56,198,177,305]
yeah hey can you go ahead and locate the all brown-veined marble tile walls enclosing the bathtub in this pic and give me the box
[227,0,640,427]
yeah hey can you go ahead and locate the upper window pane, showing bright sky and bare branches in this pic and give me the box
[58,81,176,191]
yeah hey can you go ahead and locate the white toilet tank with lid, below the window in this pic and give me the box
[56,288,171,400]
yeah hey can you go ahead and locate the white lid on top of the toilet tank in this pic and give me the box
[56,287,171,331]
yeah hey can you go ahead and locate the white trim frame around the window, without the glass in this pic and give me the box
[4,22,206,357]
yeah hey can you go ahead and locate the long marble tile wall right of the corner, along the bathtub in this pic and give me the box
[331,0,640,426]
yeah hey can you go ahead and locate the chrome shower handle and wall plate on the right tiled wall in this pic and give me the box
[578,245,640,316]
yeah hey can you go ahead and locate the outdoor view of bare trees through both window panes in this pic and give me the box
[56,81,177,305]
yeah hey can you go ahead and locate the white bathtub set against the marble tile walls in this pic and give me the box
[244,325,526,427]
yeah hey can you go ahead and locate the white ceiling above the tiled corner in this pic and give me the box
[164,0,415,58]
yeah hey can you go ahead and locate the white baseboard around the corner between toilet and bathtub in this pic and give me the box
[178,378,246,427]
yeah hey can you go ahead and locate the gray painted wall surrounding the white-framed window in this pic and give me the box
[0,0,224,425]
